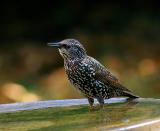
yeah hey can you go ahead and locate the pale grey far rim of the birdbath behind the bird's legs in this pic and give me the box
[0,98,126,113]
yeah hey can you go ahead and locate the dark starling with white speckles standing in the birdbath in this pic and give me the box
[48,39,139,109]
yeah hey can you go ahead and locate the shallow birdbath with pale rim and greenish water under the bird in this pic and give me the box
[0,98,160,131]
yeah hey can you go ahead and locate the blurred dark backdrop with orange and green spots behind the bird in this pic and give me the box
[0,0,160,103]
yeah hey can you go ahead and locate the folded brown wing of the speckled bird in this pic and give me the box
[88,57,138,97]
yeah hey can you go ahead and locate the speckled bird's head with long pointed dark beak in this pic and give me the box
[48,39,86,60]
